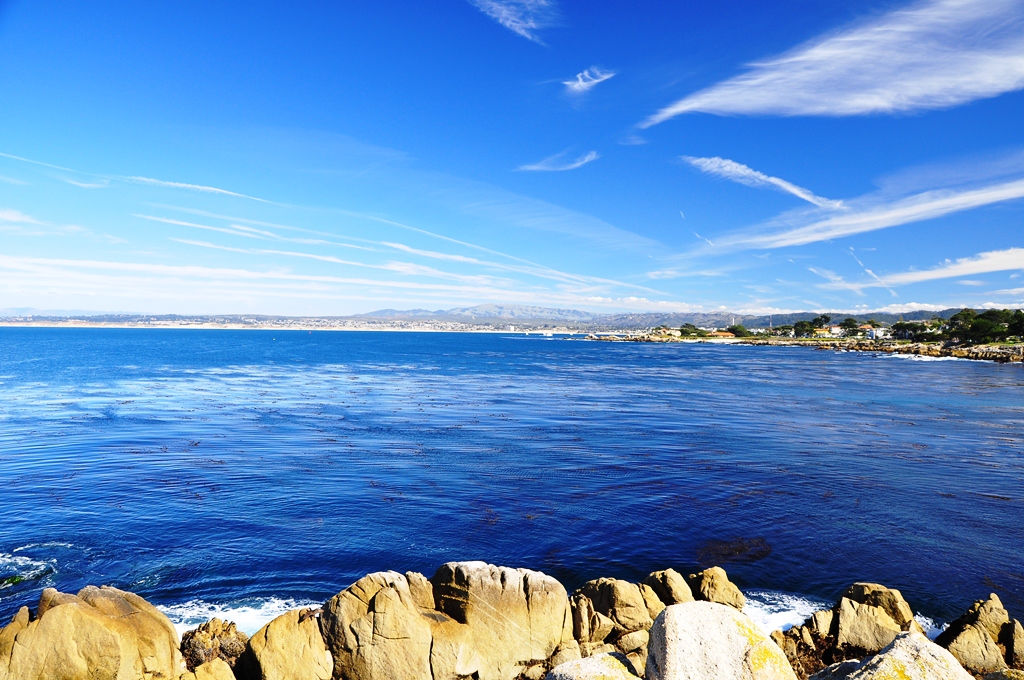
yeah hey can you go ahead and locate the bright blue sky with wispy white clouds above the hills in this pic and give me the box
[0,0,1024,315]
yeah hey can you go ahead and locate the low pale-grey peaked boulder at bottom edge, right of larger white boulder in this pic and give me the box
[811,633,972,680]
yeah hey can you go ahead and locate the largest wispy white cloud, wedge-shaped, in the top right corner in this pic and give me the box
[640,0,1024,127]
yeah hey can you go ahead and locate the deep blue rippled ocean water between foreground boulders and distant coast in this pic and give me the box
[0,329,1024,628]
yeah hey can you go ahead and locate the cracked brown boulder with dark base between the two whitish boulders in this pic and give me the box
[772,583,923,678]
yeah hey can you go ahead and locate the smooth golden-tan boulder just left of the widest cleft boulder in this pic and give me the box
[234,609,334,680]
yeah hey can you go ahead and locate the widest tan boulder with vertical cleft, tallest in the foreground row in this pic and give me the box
[322,562,579,680]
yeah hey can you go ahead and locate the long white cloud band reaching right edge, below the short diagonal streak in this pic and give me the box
[719,179,1024,248]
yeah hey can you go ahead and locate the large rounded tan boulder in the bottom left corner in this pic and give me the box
[0,586,184,680]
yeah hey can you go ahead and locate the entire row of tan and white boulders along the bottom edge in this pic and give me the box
[0,562,1024,680]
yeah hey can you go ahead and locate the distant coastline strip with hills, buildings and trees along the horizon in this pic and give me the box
[0,305,1024,363]
